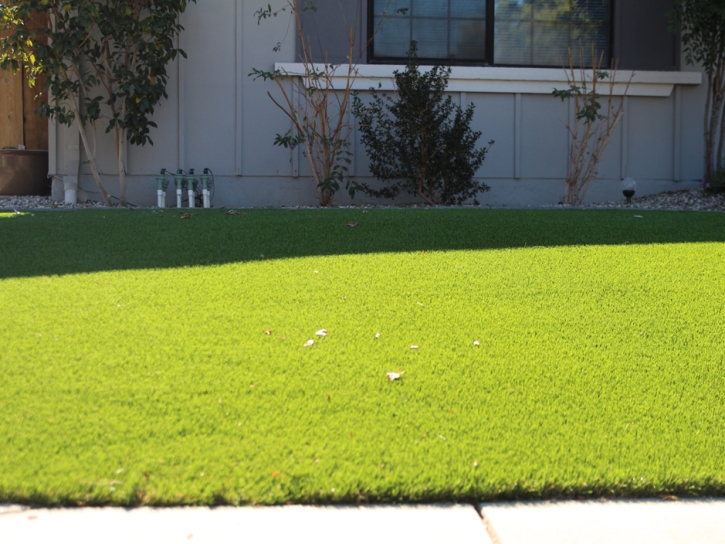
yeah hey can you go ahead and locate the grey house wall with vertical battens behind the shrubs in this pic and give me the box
[55,0,705,207]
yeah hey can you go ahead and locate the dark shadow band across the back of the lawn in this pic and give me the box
[0,209,725,278]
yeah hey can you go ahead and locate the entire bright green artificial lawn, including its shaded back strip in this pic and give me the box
[0,210,725,504]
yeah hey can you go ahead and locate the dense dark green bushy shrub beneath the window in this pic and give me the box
[352,42,493,206]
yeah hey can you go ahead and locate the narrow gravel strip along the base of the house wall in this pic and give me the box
[0,189,725,212]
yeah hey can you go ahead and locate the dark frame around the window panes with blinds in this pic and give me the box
[367,0,618,68]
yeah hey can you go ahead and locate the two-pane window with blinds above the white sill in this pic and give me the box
[369,0,611,66]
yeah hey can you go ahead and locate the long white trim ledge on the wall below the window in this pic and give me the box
[274,62,702,97]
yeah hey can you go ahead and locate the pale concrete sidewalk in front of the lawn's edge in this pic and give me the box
[0,500,725,544]
